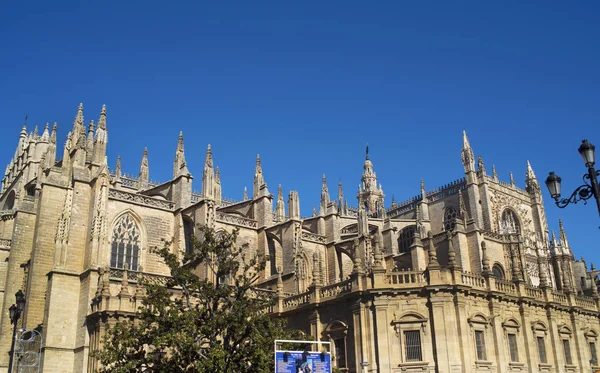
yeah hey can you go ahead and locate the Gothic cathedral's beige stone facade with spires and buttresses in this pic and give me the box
[0,105,600,373]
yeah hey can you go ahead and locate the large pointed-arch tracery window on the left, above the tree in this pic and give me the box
[110,214,141,271]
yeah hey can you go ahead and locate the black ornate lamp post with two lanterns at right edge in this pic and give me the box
[546,140,600,214]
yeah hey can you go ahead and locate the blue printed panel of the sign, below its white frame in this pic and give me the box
[275,351,331,373]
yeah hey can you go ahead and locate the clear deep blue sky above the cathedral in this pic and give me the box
[0,0,600,264]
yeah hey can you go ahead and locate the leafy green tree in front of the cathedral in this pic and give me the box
[95,228,294,373]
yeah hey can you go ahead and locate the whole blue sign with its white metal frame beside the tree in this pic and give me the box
[275,340,331,373]
